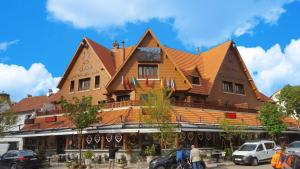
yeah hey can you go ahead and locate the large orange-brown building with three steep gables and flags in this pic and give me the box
[8,30,298,160]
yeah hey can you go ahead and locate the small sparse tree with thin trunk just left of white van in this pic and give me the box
[220,118,246,155]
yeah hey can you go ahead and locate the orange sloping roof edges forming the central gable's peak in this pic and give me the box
[106,29,192,88]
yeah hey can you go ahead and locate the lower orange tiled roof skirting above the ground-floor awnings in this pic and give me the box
[22,107,297,131]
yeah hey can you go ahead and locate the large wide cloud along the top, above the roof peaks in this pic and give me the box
[47,0,292,46]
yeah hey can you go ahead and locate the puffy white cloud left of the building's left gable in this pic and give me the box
[0,63,60,101]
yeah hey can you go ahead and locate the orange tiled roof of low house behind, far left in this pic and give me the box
[12,96,50,113]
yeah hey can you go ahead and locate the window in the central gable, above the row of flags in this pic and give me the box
[137,63,159,80]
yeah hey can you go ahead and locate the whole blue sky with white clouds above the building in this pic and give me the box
[0,0,300,100]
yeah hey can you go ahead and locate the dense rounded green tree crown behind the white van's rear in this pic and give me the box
[258,102,287,137]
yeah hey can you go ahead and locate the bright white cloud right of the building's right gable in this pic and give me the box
[238,39,300,95]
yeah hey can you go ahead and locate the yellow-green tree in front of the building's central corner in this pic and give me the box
[142,89,176,149]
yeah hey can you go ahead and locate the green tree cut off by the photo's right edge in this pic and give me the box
[275,85,300,128]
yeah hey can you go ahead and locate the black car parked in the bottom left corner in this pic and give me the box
[0,150,42,169]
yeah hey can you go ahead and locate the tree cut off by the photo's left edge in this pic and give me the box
[0,98,17,136]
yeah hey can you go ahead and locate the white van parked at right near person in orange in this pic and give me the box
[232,140,276,165]
